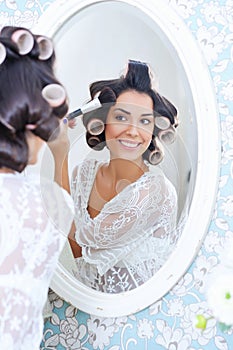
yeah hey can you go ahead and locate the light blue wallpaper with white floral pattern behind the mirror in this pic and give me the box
[0,0,233,350]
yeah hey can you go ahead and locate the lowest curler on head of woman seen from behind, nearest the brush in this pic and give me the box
[42,84,66,107]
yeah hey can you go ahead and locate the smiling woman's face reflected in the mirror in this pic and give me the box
[105,90,154,160]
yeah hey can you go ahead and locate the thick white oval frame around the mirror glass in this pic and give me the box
[33,0,220,317]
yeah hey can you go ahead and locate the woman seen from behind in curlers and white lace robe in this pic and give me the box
[0,27,73,350]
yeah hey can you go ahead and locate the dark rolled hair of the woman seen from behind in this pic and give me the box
[0,26,68,172]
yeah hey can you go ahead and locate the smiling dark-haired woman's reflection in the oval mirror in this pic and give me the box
[52,61,180,293]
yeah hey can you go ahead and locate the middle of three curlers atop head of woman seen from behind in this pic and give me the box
[11,29,34,55]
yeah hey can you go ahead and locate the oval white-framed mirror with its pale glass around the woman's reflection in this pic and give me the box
[31,0,220,317]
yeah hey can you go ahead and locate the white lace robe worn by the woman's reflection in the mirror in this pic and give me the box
[71,160,177,293]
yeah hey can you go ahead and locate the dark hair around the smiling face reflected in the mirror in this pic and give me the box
[83,60,177,161]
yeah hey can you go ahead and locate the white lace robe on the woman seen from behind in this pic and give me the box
[0,174,74,350]
